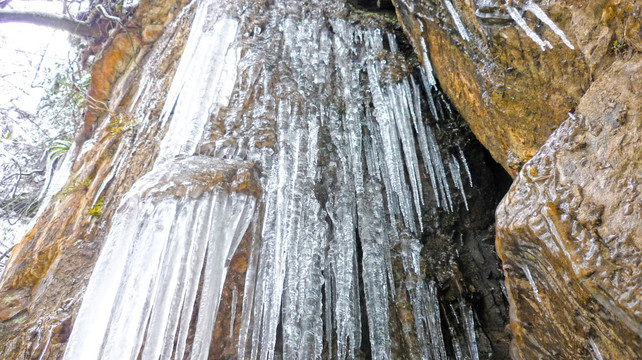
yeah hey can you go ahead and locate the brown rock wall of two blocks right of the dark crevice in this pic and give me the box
[395,0,642,359]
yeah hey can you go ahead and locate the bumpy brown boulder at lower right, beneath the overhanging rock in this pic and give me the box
[496,54,642,359]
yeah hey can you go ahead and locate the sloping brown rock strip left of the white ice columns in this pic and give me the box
[0,2,190,359]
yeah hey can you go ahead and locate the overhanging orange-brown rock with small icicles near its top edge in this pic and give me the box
[394,0,642,176]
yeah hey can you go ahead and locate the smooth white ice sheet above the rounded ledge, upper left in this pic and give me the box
[158,8,239,162]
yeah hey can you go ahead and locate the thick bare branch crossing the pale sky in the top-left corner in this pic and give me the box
[0,10,102,39]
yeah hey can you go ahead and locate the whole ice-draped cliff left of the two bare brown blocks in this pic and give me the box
[0,1,509,359]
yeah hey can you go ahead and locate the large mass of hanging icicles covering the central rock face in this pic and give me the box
[65,0,476,359]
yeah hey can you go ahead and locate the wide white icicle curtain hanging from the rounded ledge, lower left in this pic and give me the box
[65,159,254,359]
